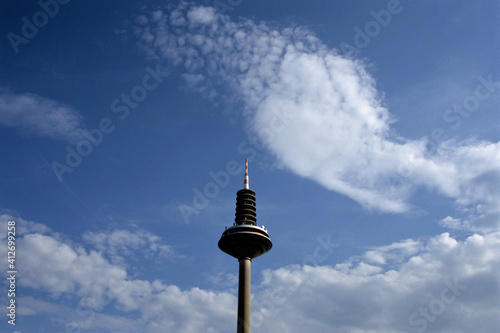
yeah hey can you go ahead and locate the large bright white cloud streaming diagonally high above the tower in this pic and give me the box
[130,2,500,230]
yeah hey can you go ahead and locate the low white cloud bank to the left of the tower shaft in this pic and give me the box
[18,234,236,332]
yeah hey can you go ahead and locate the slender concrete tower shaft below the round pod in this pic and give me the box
[237,258,252,333]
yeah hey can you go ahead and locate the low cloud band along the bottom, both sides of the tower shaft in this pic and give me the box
[0,216,500,333]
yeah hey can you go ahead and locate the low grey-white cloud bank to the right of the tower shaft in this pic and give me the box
[253,233,500,332]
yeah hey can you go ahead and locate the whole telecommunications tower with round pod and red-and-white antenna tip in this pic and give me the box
[219,159,273,333]
